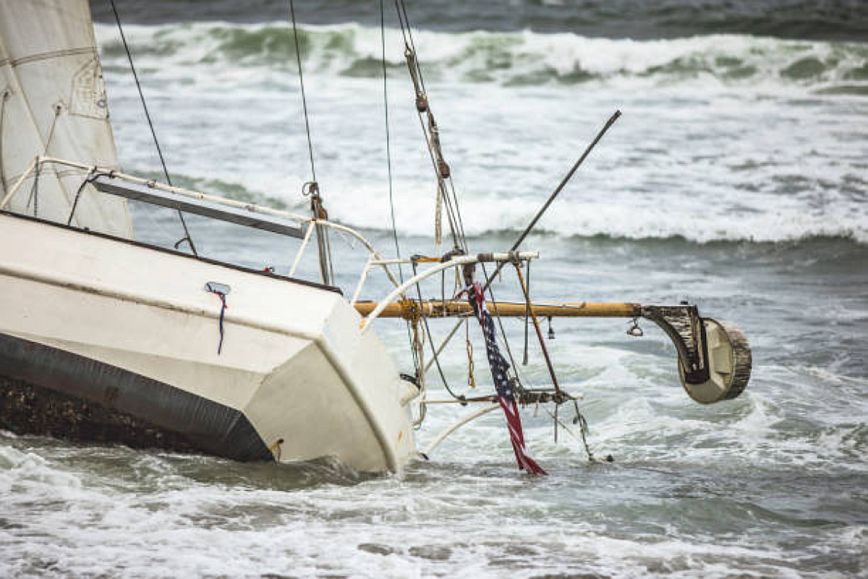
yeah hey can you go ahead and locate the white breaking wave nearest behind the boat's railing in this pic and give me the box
[161,175,868,246]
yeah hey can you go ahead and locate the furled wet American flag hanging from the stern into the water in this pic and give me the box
[471,282,547,474]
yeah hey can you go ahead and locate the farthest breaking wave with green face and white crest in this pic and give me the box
[97,22,868,95]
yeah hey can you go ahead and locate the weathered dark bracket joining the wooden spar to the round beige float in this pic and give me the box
[641,306,709,384]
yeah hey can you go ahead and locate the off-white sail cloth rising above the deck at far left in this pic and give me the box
[0,0,133,238]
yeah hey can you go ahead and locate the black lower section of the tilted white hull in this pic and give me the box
[0,334,274,461]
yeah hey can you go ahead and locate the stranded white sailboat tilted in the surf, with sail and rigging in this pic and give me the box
[0,0,750,473]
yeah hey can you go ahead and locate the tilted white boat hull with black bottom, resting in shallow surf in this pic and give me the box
[0,214,416,472]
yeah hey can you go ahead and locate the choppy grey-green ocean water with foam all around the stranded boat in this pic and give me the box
[0,0,868,577]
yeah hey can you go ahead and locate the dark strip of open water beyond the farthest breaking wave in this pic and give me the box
[92,0,868,41]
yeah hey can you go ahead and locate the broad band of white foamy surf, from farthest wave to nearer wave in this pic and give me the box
[98,23,868,243]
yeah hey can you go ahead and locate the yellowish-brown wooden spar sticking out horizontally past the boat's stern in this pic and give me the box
[354,300,642,319]
